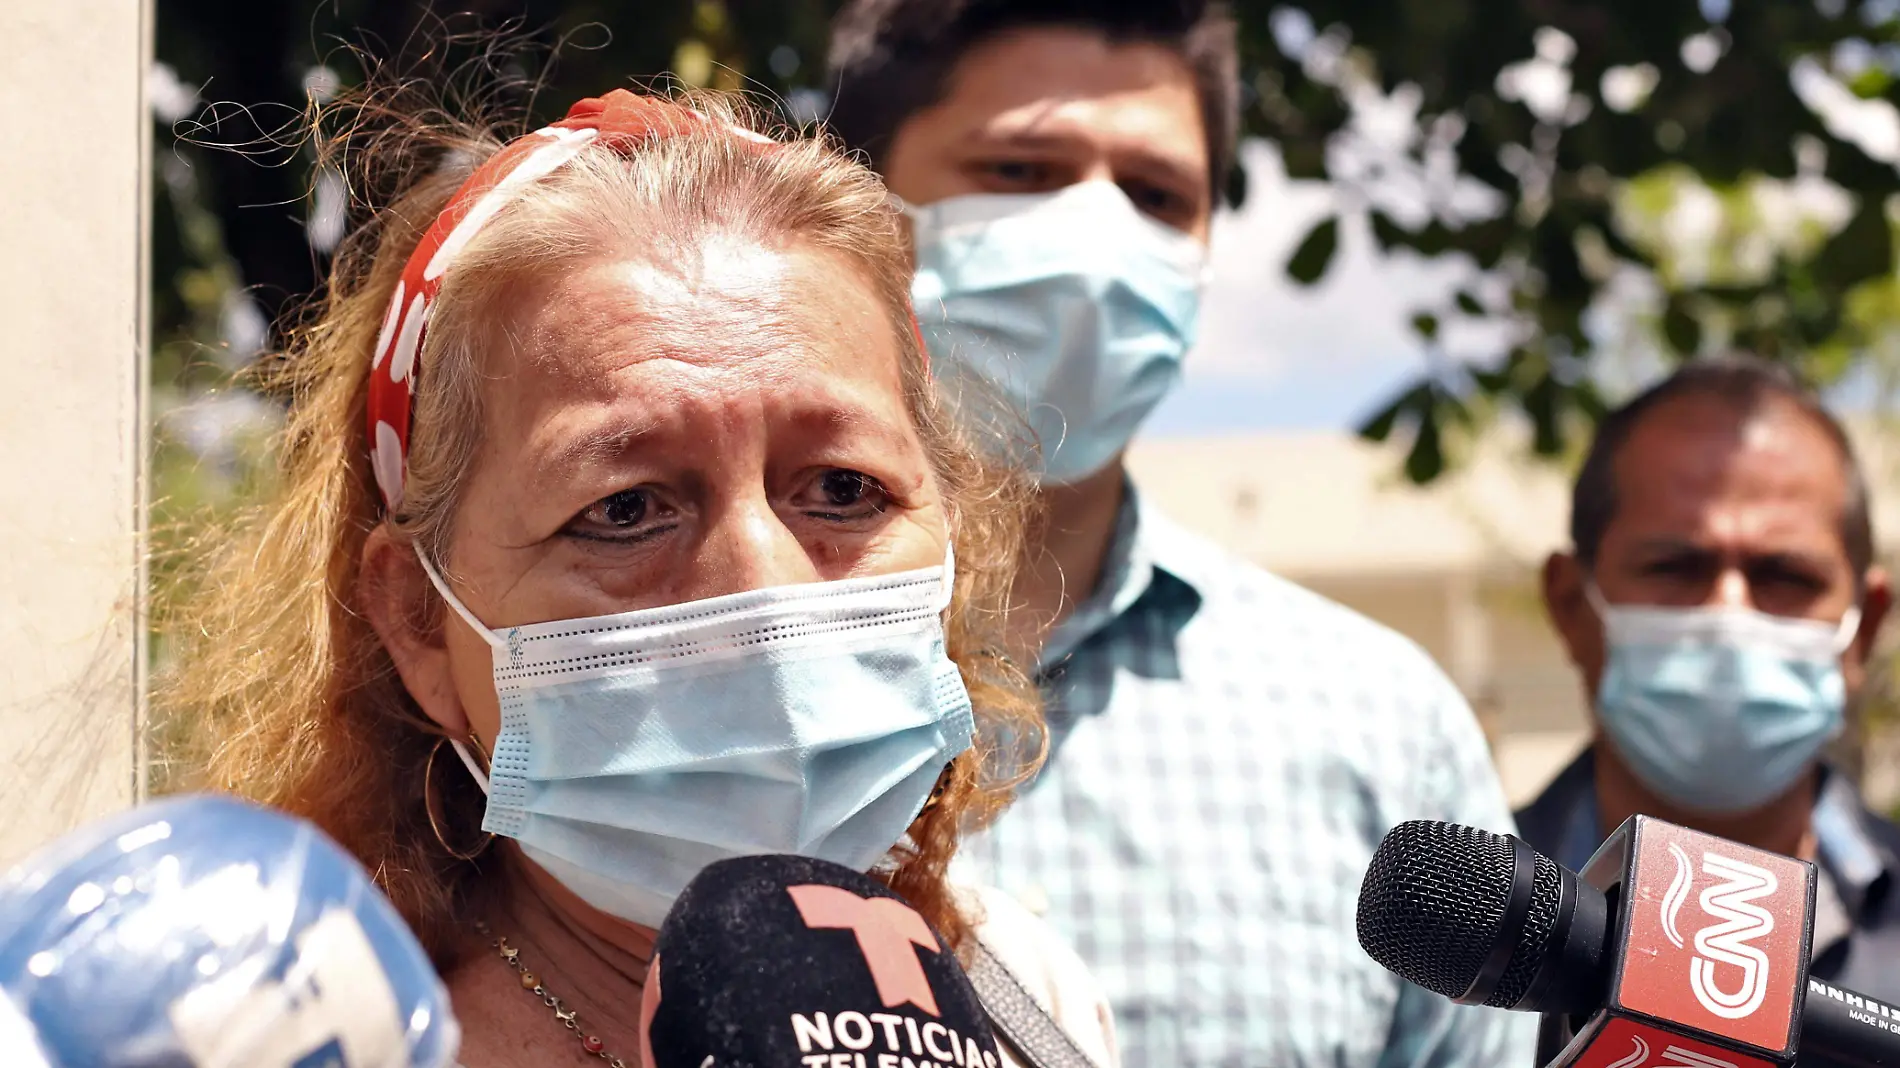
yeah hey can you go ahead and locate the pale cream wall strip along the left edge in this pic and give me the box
[0,0,152,861]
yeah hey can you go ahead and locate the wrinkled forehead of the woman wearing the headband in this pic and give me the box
[478,241,910,471]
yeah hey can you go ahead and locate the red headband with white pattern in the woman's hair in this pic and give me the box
[369,89,773,513]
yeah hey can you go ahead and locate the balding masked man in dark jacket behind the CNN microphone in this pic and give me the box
[1518,357,1900,1000]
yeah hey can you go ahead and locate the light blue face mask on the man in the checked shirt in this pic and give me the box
[904,181,1207,485]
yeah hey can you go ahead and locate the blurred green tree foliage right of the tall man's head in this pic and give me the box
[1243,0,1900,481]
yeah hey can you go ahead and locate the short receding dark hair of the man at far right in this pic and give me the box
[1569,355,1873,580]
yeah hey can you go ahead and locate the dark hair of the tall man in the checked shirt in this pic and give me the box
[828,0,1241,203]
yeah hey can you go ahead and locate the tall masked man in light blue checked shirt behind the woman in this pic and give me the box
[830,0,1535,1068]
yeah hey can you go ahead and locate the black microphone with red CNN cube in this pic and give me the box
[1359,815,1900,1068]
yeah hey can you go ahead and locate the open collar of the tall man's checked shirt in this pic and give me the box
[1037,477,1205,671]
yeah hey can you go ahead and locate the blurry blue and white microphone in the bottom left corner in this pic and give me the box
[0,796,460,1068]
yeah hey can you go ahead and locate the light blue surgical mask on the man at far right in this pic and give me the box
[1587,583,1860,813]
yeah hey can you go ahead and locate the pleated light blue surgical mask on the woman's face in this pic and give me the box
[424,555,973,927]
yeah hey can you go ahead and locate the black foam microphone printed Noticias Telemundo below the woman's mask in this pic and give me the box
[640,855,1001,1068]
